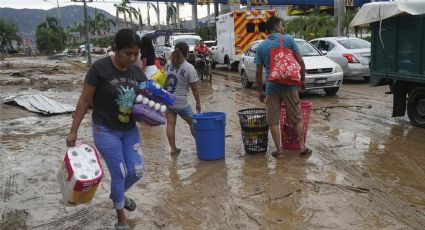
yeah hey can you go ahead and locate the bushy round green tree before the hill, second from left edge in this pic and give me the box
[35,17,66,54]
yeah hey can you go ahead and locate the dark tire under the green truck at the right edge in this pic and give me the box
[407,87,425,128]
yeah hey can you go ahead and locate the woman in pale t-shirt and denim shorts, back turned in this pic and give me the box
[165,42,201,154]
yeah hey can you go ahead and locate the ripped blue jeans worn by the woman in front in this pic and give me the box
[93,123,145,209]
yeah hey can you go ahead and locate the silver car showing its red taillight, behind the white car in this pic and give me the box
[310,37,370,80]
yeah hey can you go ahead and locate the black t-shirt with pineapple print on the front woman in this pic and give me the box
[85,57,147,130]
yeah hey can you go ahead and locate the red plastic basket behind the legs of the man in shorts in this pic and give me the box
[280,101,313,150]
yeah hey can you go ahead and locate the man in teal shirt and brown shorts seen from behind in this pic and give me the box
[254,16,311,158]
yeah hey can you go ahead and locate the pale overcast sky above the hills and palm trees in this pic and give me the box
[0,0,214,22]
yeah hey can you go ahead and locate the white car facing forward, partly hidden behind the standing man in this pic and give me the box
[238,39,343,95]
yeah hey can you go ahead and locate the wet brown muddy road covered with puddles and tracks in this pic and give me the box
[0,58,425,229]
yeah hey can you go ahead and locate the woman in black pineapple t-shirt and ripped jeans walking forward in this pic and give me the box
[66,29,147,229]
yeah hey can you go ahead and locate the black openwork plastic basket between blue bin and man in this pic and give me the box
[238,108,269,153]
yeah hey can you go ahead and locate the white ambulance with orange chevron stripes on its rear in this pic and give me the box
[216,10,278,70]
